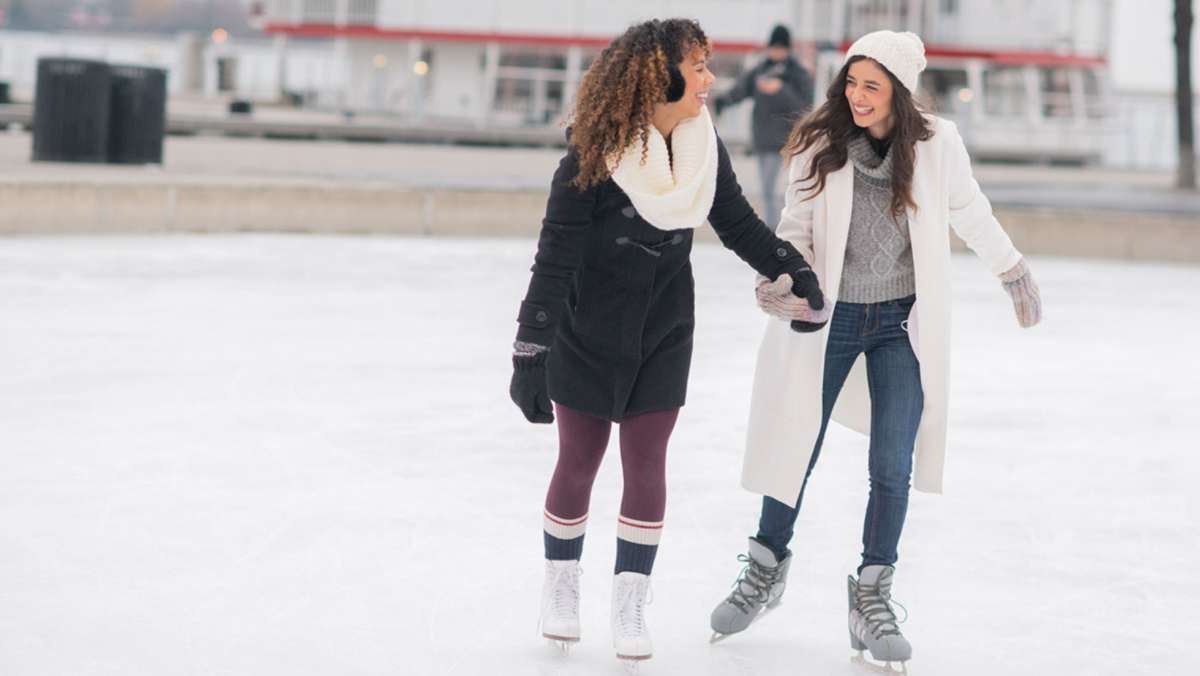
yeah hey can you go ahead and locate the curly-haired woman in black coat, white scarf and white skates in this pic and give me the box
[510,19,828,664]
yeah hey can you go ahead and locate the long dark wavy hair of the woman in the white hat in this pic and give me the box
[782,56,934,226]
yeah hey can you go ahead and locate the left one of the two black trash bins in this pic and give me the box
[34,58,113,162]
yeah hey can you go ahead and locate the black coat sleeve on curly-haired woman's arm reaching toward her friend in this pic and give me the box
[708,138,809,280]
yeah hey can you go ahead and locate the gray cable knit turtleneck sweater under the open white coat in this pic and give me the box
[838,136,917,303]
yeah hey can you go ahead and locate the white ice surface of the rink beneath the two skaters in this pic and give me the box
[0,235,1200,676]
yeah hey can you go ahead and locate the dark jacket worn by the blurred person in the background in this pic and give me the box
[714,54,812,152]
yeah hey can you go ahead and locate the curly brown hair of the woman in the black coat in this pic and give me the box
[568,19,713,190]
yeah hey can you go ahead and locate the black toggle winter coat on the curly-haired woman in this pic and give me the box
[517,132,806,423]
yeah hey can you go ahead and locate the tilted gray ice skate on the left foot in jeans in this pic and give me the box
[709,538,792,644]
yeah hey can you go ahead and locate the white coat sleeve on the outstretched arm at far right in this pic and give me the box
[936,120,1021,275]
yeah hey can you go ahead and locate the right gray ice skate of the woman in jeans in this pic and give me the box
[846,566,912,675]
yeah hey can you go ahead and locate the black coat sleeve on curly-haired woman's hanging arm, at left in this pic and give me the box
[517,148,600,347]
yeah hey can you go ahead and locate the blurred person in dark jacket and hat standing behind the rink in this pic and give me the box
[713,25,812,229]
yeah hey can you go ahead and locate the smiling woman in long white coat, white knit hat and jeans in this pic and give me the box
[712,31,1042,669]
